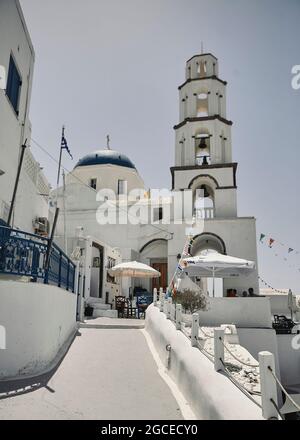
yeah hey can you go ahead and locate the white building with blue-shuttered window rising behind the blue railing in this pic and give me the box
[0,0,50,232]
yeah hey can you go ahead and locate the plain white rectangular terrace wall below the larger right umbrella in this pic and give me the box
[197,297,272,328]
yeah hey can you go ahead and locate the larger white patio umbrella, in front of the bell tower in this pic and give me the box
[183,252,255,296]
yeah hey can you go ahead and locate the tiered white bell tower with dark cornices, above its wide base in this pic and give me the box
[171,54,237,218]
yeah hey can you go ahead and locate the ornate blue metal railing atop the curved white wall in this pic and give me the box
[0,226,75,292]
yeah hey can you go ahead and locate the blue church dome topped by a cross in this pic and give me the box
[75,149,135,169]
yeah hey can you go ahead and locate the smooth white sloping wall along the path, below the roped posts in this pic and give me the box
[145,305,262,420]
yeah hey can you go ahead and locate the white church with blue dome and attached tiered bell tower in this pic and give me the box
[52,50,258,296]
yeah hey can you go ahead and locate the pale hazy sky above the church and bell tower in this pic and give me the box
[21,0,300,293]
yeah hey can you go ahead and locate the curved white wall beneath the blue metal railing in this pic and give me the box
[0,280,77,380]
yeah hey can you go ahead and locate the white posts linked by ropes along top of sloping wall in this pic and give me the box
[153,288,300,419]
